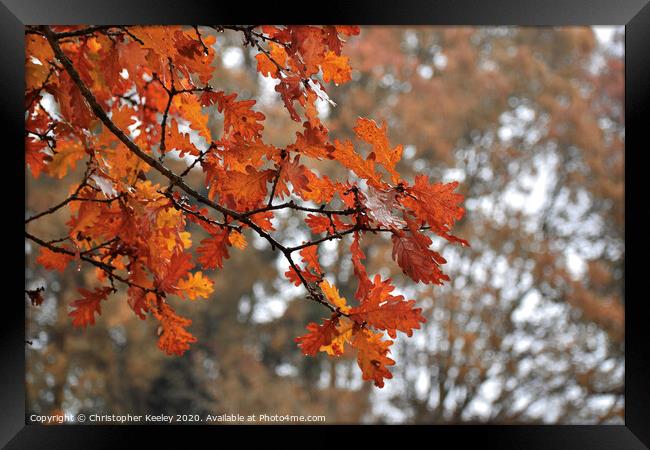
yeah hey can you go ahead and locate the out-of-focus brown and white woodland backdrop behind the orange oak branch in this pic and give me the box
[25,27,625,423]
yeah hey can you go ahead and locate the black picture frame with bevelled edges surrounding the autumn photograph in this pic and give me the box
[6,0,650,449]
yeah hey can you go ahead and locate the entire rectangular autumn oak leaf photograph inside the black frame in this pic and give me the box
[25,25,625,424]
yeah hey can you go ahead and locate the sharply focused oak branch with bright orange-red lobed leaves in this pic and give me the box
[25,26,468,387]
